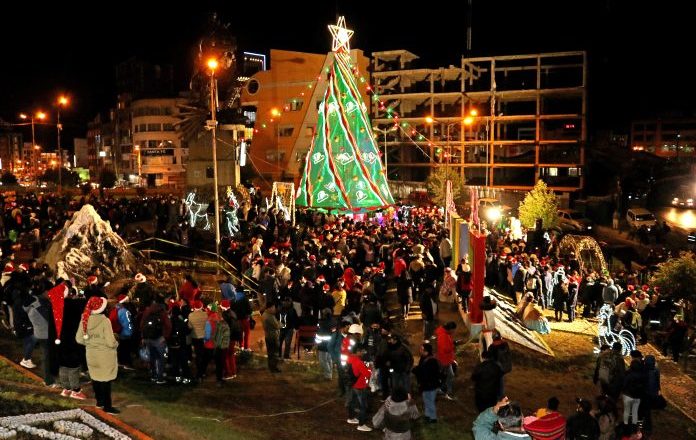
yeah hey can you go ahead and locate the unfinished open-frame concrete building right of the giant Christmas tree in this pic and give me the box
[371,50,587,192]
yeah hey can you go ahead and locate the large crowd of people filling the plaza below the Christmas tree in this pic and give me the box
[1,187,686,439]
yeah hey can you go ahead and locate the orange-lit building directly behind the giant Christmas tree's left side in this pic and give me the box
[241,49,369,182]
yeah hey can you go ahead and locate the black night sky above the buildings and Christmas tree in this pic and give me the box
[0,0,696,150]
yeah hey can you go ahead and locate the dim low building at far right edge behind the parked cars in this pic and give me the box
[631,118,696,160]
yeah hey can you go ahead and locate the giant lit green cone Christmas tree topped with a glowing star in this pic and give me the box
[296,17,394,212]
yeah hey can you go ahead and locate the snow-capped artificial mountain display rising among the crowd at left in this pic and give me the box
[43,205,135,283]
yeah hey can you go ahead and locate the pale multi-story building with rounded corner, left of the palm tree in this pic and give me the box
[131,98,188,187]
